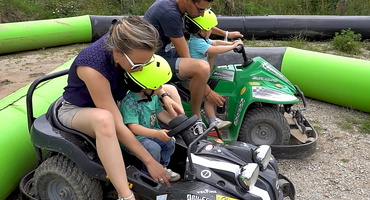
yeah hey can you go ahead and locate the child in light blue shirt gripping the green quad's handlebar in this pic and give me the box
[185,9,243,129]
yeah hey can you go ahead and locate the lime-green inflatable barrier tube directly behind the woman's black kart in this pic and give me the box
[0,58,74,199]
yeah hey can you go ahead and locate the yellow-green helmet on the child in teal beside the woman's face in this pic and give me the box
[124,55,172,92]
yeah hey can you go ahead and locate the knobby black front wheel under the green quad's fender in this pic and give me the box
[239,107,290,145]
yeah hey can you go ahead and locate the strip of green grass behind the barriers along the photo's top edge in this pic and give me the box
[0,0,370,23]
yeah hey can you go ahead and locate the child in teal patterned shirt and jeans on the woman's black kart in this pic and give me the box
[120,55,180,182]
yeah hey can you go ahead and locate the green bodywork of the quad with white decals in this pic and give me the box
[183,57,299,142]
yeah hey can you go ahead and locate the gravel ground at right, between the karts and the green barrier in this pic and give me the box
[278,99,370,200]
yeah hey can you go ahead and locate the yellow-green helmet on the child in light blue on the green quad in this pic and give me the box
[185,9,218,33]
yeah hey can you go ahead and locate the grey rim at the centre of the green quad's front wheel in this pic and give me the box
[251,124,276,145]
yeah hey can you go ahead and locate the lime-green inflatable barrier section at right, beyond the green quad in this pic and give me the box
[281,48,370,112]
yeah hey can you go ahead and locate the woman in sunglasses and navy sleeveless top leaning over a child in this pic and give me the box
[58,16,184,200]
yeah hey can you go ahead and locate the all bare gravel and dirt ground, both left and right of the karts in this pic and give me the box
[0,45,370,200]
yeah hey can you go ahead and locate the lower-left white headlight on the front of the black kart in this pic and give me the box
[238,163,260,191]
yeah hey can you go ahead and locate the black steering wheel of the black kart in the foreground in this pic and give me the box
[167,114,198,137]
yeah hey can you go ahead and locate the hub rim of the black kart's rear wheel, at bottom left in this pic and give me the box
[47,179,76,200]
